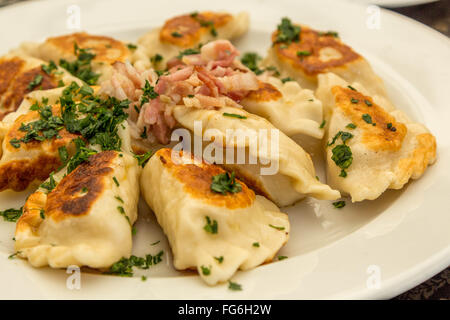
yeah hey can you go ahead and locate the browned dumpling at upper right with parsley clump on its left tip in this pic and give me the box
[264,18,389,109]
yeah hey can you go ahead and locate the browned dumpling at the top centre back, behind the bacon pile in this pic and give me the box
[138,11,249,69]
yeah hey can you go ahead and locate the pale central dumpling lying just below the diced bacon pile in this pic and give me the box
[173,106,340,206]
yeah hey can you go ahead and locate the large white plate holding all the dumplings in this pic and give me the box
[0,0,450,299]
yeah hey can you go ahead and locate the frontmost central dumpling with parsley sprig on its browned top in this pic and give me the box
[141,148,289,285]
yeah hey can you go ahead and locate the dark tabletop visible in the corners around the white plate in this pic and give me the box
[0,0,450,300]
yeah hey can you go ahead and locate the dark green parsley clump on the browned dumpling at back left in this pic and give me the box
[59,42,100,85]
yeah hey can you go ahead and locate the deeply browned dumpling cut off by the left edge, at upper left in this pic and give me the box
[0,54,78,120]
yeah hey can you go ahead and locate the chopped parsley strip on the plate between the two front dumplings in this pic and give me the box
[105,251,164,277]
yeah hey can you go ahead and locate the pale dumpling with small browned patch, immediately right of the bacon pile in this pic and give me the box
[240,76,324,139]
